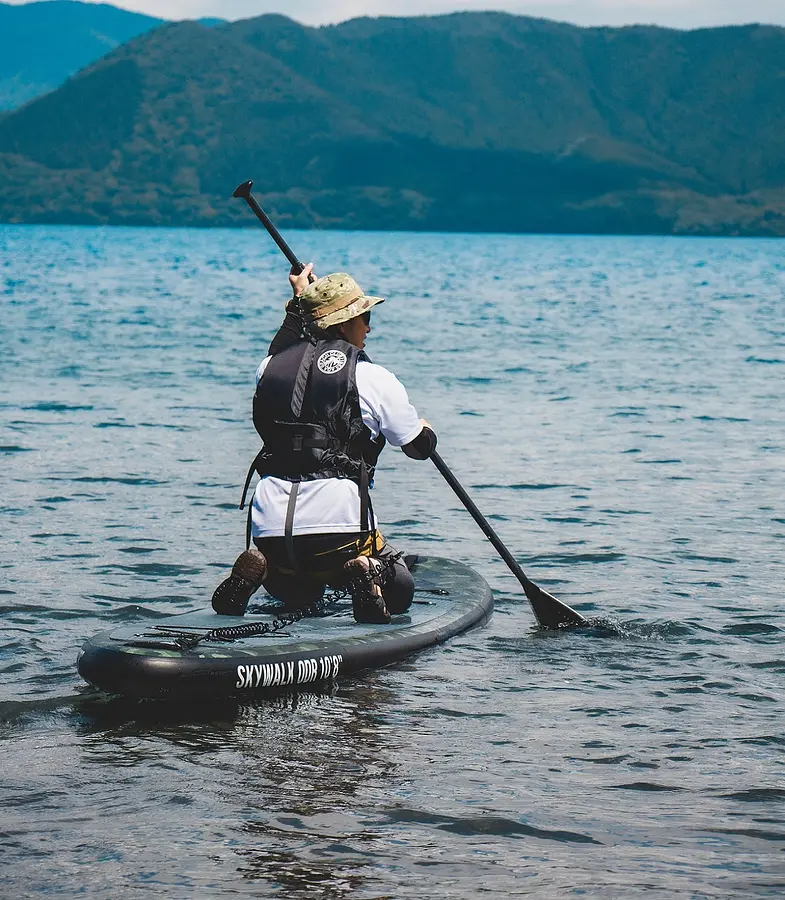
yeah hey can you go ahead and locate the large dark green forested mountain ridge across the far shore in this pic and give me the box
[0,13,785,234]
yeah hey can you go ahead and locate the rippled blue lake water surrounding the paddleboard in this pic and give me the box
[0,227,785,900]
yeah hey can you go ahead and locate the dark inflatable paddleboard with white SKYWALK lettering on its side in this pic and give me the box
[77,557,493,701]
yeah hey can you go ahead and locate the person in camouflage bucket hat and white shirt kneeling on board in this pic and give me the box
[212,264,436,624]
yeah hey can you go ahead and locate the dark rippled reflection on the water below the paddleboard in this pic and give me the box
[73,680,413,897]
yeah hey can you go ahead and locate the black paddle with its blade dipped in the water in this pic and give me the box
[232,181,587,628]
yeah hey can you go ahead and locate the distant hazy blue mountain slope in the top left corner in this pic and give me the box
[0,0,163,110]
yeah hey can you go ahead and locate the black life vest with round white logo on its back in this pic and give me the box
[241,340,386,548]
